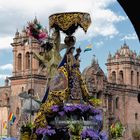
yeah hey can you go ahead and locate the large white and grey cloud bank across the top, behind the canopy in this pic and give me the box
[0,0,126,39]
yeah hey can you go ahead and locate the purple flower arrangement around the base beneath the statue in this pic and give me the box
[36,104,108,140]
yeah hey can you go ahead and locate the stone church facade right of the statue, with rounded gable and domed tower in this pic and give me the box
[83,43,140,140]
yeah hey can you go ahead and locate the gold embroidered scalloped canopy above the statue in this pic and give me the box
[49,12,91,34]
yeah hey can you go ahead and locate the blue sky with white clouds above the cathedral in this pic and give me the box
[0,0,140,85]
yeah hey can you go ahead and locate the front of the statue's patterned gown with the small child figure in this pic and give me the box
[68,48,88,101]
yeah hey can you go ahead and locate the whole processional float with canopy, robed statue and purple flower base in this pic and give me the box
[21,12,107,140]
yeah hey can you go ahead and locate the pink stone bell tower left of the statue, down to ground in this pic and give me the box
[10,18,47,136]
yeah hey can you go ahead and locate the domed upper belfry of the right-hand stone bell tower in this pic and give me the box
[106,43,140,89]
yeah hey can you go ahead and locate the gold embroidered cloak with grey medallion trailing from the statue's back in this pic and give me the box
[34,53,68,129]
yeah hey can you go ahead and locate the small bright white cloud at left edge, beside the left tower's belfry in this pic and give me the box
[0,36,12,50]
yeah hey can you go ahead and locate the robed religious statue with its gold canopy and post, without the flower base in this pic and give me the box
[29,12,91,139]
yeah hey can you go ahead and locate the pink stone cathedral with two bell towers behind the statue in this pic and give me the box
[0,19,140,140]
